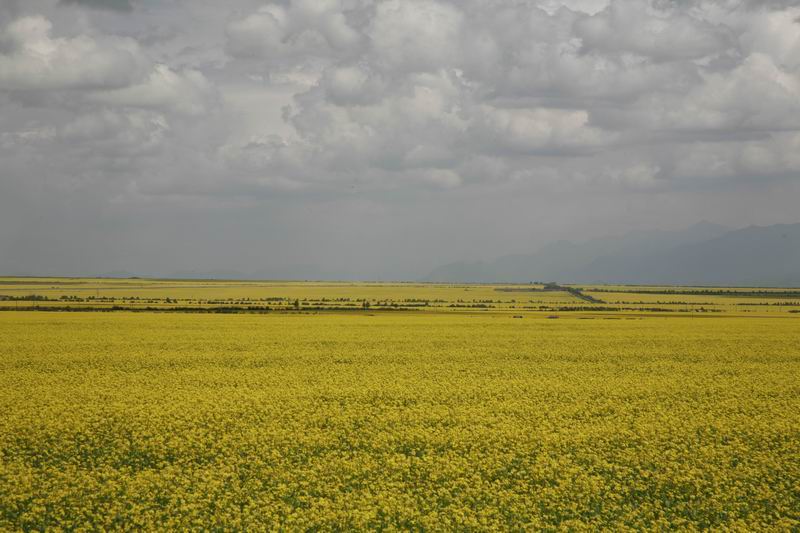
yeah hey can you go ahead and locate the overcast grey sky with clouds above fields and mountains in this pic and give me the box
[0,0,800,280]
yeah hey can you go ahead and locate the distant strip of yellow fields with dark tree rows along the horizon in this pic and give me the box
[6,277,800,316]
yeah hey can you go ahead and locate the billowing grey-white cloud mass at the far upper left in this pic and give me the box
[0,11,220,203]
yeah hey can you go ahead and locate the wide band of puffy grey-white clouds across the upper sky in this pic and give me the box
[7,0,800,202]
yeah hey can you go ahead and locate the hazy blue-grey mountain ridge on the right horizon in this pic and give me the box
[425,222,800,286]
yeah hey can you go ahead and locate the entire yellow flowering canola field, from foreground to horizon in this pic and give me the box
[0,278,800,531]
